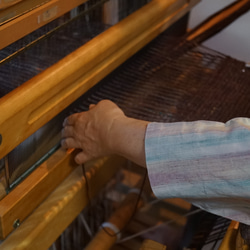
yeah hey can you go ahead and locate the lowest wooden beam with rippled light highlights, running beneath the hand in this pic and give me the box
[0,157,125,250]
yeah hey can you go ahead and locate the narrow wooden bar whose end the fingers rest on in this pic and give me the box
[0,149,76,239]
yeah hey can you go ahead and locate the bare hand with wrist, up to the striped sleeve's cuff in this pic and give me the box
[61,100,148,166]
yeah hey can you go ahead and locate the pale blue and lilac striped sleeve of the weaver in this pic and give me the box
[145,118,250,224]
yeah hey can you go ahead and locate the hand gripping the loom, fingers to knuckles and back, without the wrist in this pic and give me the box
[61,100,126,164]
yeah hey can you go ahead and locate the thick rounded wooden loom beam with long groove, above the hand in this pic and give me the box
[0,0,198,158]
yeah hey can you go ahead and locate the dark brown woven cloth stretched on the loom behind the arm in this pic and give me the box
[79,34,250,122]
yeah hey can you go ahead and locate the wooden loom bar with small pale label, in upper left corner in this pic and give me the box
[0,0,87,49]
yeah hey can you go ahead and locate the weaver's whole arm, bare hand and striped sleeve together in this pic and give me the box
[62,100,250,224]
